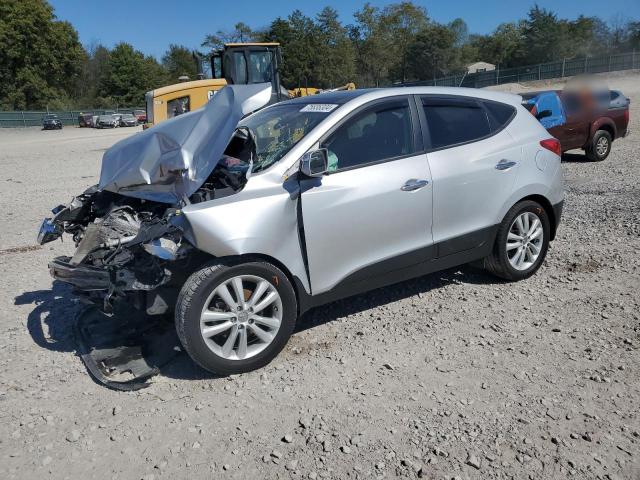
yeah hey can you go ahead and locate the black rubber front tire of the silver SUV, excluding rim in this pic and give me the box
[175,260,297,375]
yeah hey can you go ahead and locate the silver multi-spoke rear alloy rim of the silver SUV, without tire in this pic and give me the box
[507,212,544,271]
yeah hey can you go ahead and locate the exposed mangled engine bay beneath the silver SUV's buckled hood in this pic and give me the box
[38,128,255,315]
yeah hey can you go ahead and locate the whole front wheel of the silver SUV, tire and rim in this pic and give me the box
[176,261,297,375]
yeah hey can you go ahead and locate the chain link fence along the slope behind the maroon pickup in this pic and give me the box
[403,51,640,88]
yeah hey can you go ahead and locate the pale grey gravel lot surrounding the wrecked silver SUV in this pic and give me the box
[0,74,640,479]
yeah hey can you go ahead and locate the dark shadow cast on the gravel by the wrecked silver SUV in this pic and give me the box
[14,265,501,383]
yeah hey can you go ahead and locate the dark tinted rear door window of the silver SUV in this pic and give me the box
[422,98,491,148]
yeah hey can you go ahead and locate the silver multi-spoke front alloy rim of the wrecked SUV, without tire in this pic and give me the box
[200,275,282,360]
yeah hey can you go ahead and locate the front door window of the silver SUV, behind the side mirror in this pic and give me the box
[322,99,413,172]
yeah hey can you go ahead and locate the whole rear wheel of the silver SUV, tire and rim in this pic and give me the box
[485,200,551,280]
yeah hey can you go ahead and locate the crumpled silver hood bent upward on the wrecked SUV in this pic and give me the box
[99,83,271,203]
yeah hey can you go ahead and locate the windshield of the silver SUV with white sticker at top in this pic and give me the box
[238,103,338,172]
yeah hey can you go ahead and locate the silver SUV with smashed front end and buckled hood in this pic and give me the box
[39,84,563,374]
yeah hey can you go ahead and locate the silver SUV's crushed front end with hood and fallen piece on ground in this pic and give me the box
[38,84,271,390]
